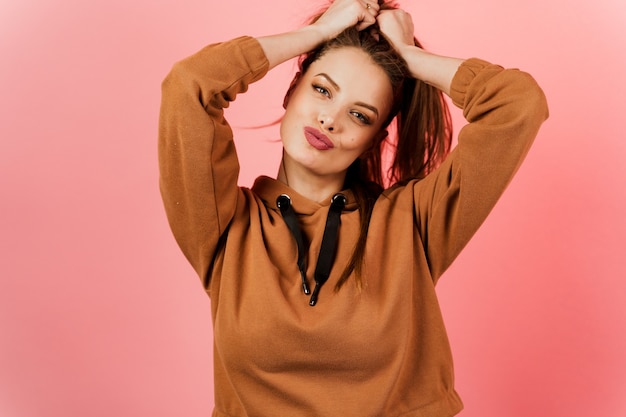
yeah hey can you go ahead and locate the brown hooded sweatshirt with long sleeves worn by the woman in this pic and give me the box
[159,37,548,417]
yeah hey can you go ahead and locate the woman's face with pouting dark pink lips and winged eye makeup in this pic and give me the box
[280,47,393,180]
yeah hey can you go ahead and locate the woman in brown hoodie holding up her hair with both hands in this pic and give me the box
[159,0,547,417]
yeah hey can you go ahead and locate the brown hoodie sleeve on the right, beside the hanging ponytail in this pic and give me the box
[413,59,548,281]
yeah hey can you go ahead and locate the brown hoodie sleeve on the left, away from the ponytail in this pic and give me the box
[158,37,268,286]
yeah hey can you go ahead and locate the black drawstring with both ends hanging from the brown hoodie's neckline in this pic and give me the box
[276,193,347,306]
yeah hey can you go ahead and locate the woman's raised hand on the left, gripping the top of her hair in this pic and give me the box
[313,0,380,39]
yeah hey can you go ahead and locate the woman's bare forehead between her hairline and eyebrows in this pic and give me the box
[307,47,392,101]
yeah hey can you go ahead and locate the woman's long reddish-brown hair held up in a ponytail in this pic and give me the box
[285,0,452,290]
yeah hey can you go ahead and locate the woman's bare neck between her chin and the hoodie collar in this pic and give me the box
[276,155,346,202]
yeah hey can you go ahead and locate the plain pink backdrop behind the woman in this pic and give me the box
[0,0,626,417]
